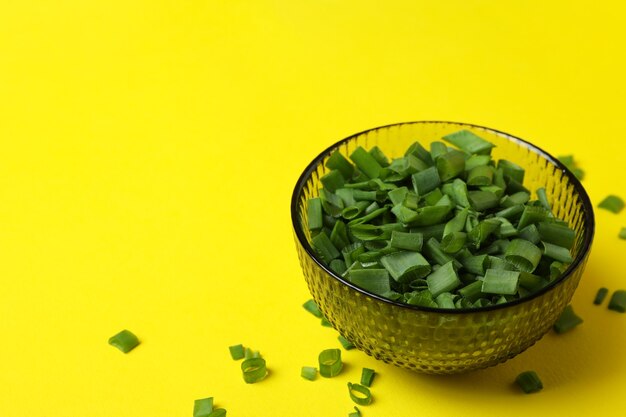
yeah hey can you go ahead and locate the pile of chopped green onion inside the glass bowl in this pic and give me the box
[307,130,576,308]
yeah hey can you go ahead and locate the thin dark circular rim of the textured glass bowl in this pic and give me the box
[291,120,595,314]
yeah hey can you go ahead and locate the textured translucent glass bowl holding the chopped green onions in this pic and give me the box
[291,122,594,374]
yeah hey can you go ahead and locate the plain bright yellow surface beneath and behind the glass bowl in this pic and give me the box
[0,0,626,417]
